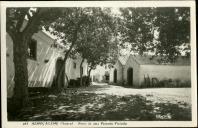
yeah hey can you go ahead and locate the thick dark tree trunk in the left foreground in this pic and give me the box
[13,34,28,109]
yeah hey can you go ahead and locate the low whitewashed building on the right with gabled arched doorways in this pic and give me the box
[110,55,191,87]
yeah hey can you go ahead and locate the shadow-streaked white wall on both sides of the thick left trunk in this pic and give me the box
[6,31,61,97]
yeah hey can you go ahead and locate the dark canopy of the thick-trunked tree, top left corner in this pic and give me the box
[6,8,61,38]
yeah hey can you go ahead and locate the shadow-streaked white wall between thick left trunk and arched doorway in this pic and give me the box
[28,31,62,87]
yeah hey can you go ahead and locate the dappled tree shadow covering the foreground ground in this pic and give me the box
[8,86,191,121]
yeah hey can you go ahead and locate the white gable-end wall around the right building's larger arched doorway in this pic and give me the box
[123,56,140,86]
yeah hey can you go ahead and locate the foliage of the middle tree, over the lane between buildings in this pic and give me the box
[45,7,118,85]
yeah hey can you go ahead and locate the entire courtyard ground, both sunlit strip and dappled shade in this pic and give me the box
[9,83,191,121]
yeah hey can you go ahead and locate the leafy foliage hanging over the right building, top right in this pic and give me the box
[120,7,190,62]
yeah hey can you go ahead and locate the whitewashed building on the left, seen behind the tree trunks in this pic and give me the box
[6,31,87,97]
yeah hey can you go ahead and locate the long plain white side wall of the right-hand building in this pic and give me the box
[139,65,191,83]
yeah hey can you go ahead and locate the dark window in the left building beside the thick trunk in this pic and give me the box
[28,39,37,60]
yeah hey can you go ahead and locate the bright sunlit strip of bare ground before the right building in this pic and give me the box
[89,83,191,105]
